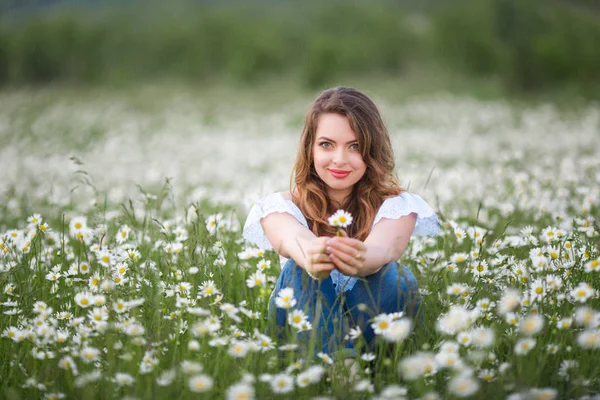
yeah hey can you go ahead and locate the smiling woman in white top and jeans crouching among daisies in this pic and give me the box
[244,87,438,355]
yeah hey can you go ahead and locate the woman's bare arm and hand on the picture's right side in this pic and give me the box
[327,213,417,276]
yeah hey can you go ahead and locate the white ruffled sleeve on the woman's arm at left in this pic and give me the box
[242,193,308,250]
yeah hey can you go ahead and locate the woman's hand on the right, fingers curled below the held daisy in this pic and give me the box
[326,230,367,276]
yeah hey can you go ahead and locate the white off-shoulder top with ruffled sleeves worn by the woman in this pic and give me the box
[243,192,439,293]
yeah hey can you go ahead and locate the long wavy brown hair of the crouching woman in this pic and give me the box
[290,87,403,240]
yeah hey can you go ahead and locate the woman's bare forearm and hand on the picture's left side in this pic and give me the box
[260,213,334,278]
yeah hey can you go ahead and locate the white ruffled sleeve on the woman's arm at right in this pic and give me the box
[373,192,440,235]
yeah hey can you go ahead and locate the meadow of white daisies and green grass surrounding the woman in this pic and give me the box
[0,86,600,400]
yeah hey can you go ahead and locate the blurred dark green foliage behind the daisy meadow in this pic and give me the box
[0,0,600,99]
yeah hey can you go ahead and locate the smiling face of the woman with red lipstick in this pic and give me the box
[312,113,367,204]
